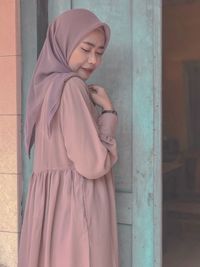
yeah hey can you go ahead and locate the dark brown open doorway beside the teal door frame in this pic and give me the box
[162,0,200,267]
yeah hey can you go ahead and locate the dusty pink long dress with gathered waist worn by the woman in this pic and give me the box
[18,77,119,267]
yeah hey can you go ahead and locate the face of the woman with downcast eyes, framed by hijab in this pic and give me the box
[68,28,105,80]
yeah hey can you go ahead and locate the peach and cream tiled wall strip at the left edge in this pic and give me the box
[0,0,22,267]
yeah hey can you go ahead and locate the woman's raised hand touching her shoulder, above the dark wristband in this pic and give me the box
[88,84,113,109]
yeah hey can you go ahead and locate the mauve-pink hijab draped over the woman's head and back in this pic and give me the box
[24,8,110,158]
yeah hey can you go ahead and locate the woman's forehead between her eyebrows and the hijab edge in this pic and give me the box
[81,29,105,48]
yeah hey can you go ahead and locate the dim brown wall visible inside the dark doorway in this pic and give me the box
[163,1,200,150]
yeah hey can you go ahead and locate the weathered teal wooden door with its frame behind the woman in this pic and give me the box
[21,0,162,267]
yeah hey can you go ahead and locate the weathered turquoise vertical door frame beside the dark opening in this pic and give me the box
[132,0,162,267]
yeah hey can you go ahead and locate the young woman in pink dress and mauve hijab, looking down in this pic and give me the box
[18,9,119,267]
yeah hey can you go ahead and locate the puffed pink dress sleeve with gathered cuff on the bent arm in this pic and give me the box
[60,77,118,179]
